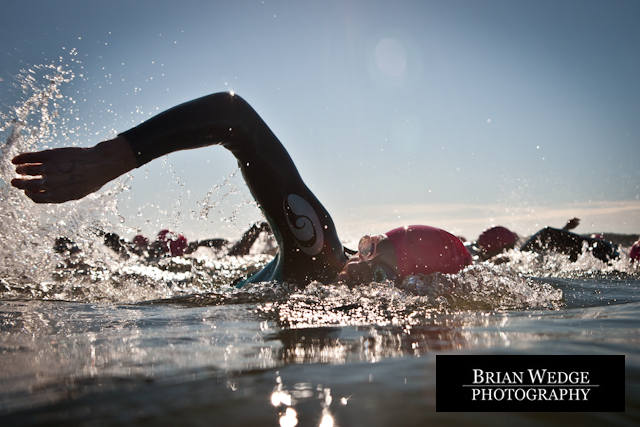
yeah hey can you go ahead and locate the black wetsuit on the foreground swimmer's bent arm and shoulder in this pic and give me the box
[121,93,347,286]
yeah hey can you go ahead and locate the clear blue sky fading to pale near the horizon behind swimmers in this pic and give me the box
[0,0,640,240]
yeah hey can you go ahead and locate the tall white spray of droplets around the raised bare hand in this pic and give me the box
[0,61,126,290]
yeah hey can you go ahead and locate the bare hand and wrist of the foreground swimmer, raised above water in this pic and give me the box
[11,137,136,203]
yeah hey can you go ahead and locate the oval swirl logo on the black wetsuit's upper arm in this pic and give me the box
[284,194,324,255]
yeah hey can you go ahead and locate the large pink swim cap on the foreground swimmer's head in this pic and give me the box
[386,225,471,277]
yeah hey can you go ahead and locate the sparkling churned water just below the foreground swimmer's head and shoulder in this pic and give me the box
[258,265,562,328]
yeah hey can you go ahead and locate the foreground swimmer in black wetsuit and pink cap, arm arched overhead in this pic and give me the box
[11,93,471,286]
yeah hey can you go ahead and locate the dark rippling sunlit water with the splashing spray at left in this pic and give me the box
[0,61,640,426]
